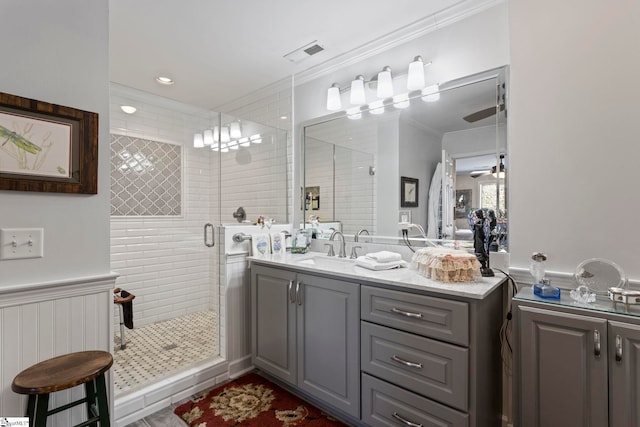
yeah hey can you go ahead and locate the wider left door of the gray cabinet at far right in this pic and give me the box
[518,306,608,427]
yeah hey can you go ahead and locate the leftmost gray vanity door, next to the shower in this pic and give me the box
[251,266,297,385]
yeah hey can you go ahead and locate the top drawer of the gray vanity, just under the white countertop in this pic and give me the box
[360,286,469,346]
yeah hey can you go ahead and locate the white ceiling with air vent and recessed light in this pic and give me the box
[109,0,472,109]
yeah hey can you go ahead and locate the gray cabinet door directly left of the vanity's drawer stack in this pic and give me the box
[298,274,360,417]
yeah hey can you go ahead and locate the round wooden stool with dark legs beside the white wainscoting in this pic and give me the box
[11,351,113,427]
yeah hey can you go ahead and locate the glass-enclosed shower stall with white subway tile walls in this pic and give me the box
[110,84,291,418]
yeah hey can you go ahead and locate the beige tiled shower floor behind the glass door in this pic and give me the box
[113,311,219,396]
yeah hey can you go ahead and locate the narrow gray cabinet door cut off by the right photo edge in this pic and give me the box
[609,322,640,427]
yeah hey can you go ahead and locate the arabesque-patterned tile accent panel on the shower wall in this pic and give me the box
[111,135,182,216]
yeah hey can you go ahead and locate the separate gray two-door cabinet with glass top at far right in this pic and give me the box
[514,289,640,427]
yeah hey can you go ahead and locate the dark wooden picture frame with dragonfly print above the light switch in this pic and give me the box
[0,92,98,194]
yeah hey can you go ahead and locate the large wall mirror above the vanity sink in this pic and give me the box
[302,67,509,250]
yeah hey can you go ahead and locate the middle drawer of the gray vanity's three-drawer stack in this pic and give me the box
[360,322,469,411]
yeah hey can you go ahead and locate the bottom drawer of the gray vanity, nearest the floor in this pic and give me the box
[362,374,469,427]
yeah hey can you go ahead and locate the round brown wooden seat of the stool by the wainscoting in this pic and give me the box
[11,350,113,394]
